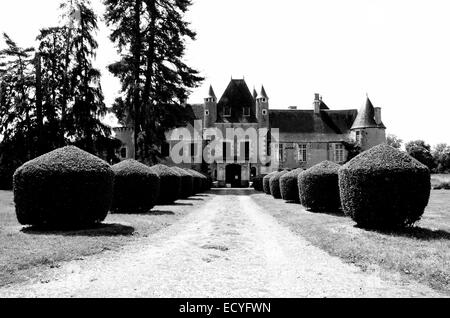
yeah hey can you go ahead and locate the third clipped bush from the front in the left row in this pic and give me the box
[150,164,181,205]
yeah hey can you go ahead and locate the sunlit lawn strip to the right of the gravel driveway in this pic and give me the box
[252,190,450,295]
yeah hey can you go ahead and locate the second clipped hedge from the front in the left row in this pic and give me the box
[111,159,160,213]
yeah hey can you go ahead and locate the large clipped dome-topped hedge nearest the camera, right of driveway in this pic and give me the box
[339,144,431,229]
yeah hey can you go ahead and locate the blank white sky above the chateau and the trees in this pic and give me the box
[0,0,450,144]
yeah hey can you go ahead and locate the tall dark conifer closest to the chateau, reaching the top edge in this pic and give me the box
[105,0,203,161]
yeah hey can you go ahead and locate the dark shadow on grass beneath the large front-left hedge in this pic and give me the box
[21,224,134,237]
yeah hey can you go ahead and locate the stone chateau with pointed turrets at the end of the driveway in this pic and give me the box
[114,79,386,187]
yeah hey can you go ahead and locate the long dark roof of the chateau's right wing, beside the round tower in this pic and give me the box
[269,109,357,135]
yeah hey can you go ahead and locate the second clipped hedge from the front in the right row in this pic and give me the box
[298,161,341,212]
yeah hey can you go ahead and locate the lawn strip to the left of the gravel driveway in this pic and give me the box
[0,191,209,287]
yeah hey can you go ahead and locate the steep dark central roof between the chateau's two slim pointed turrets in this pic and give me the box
[217,79,257,123]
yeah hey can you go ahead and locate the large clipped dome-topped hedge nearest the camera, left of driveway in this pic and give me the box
[13,146,114,229]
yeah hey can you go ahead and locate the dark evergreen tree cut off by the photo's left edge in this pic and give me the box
[0,34,37,189]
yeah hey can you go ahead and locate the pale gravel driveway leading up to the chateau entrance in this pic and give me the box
[0,189,441,297]
